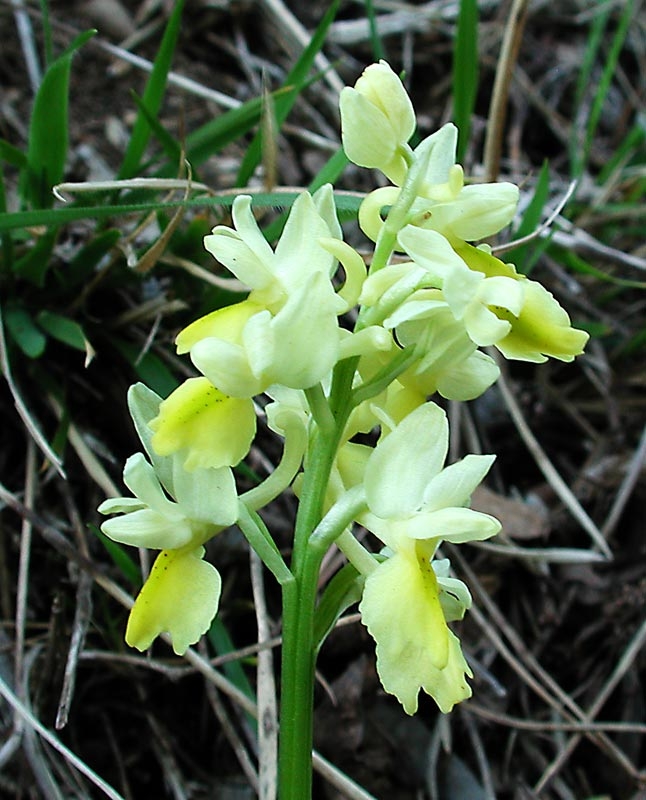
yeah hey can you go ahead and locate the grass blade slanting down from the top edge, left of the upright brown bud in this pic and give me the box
[118,0,184,178]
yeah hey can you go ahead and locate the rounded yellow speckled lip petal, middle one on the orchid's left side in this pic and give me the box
[149,378,256,471]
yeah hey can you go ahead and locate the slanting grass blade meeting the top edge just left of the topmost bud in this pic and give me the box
[236,0,340,186]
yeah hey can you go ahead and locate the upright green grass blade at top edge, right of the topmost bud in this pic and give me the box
[453,0,478,163]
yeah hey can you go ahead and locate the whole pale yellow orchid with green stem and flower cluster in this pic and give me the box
[99,61,588,800]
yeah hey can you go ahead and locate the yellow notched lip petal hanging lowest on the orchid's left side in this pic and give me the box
[126,547,222,655]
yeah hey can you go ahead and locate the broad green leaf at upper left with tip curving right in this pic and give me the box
[21,31,96,208]
